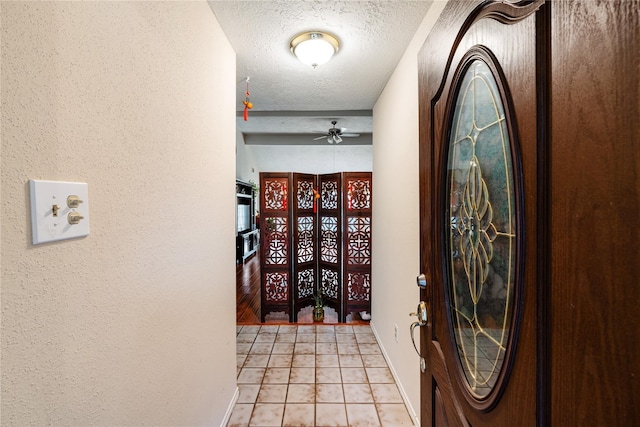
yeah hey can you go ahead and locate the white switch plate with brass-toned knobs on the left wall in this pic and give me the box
[29,179,89,245]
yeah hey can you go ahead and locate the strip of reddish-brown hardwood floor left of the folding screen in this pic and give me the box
[236,251,260,325]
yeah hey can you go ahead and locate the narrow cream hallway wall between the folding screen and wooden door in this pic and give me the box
[371,0,446,424]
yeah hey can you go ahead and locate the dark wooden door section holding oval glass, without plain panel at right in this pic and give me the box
[420,1,547,427]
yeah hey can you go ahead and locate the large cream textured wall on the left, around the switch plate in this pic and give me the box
[0,1,236,426]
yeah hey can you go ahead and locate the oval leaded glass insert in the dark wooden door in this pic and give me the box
[445,59,518,399]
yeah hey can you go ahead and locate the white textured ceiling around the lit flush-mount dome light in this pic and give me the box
[209,0,432,144]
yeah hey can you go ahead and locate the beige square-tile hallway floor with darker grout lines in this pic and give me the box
[227,325,413,427]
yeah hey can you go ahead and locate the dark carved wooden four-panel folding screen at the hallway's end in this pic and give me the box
[260,172,372,322]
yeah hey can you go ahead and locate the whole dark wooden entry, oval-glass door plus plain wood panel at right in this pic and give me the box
[419,0,640,427]
